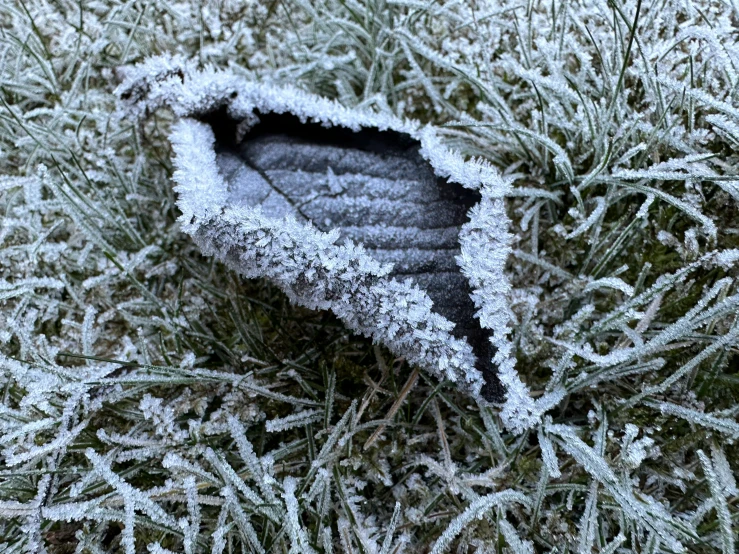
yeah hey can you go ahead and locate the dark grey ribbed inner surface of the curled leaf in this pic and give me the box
[208,112,497,396]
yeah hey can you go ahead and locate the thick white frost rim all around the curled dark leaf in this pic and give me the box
[117,57,544,416]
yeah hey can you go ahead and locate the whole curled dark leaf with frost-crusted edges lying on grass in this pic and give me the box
[118,57,561,426]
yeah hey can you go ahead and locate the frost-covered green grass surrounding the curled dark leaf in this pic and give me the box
[0,0,739,554]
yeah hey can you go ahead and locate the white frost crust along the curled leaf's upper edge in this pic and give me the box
[116,55,511,196]
